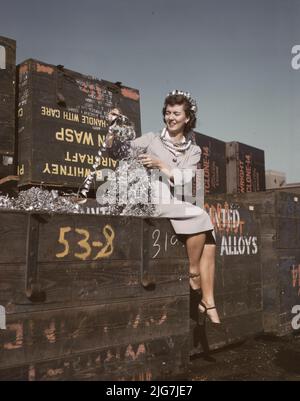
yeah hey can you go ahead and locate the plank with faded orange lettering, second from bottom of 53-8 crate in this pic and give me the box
[0,296,189,368]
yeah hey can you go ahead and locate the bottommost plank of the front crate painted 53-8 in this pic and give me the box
[0,334,189,381]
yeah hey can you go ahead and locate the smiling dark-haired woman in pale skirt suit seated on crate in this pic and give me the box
[107,90,220,325]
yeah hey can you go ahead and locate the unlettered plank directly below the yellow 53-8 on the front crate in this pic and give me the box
[0,260,188,313]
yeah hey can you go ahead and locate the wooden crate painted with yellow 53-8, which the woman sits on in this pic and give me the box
[0,211,189,380]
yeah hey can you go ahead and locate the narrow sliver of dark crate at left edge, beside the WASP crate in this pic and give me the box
[0,36,16,179]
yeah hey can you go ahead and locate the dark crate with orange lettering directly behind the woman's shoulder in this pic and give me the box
[195,132,227,195]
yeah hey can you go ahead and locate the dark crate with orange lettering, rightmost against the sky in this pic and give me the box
[226,142,266,193]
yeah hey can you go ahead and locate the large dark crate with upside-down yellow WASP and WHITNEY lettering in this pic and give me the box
[18,59,141,188]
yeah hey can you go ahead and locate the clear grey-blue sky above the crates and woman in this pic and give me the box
[0,0,300,182]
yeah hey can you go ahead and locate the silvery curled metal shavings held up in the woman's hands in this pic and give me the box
[77,109,156,217]
